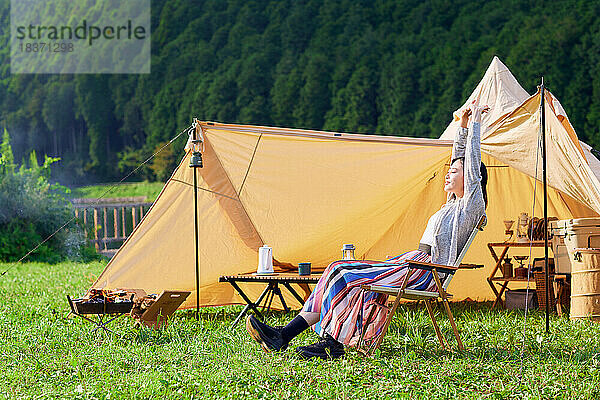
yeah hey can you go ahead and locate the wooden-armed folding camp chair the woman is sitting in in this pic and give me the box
[357,215,486,355]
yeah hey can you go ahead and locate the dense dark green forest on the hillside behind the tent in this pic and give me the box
[0,0,600,185]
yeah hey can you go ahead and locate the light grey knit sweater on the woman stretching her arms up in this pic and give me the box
[422,122,485,265]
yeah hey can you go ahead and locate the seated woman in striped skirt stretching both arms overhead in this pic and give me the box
[246,104,489,359]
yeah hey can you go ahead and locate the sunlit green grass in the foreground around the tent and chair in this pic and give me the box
[0,263,600,399]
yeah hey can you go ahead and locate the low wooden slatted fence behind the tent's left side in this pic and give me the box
[71,196,152,255]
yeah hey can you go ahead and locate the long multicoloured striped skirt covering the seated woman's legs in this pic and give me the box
[303,250,436,346]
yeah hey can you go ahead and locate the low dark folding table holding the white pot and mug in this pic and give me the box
[219,273,321,326]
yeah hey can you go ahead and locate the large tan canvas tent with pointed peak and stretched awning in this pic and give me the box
[94,58,600,308]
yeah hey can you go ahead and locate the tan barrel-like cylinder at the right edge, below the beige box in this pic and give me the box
[570,248,600,321]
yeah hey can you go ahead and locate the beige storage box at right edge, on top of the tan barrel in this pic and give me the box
[549,218,600,274]
